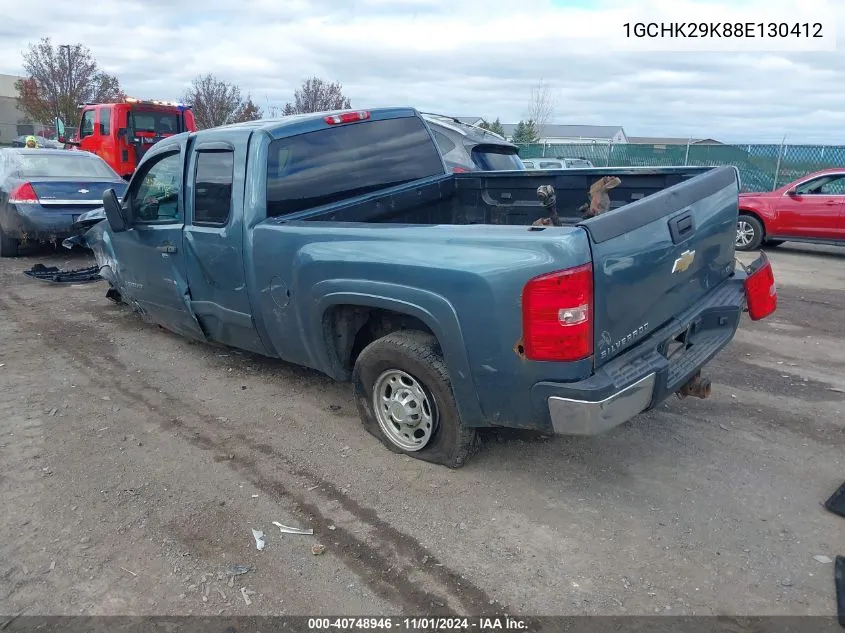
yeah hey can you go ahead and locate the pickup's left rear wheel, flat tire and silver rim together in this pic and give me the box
[352,330,478,468]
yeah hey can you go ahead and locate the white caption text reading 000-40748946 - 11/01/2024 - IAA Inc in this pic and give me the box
[308,616,528,632]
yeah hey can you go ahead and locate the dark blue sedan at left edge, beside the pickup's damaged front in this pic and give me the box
[0,148,126,257]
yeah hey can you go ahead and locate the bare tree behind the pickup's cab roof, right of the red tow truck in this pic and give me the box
[185,73,261,130]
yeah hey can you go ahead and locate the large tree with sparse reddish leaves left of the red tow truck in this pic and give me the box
[15,37,125,134]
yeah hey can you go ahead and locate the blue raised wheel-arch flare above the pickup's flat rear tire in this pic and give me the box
[302,279,483,426]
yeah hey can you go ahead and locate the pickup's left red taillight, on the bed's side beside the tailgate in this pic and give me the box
[522,264,593,362]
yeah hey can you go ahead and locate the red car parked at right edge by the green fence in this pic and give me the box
[736,168,845,251]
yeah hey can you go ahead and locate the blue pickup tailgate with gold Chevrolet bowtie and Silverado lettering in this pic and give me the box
[580,167,739,367]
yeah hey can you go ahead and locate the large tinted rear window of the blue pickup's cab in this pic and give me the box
[267,112,444,216]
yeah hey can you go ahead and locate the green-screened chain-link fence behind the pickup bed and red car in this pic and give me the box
[519,143,845,191]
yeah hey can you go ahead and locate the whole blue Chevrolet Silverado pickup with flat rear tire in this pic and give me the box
[72,108,777,468]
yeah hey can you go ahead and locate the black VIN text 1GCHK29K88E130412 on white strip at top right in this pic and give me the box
[622,22,823,39]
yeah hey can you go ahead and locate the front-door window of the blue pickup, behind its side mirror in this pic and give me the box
[129,152,183,224]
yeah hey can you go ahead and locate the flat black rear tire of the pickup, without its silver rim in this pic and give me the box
[352,330,479,468]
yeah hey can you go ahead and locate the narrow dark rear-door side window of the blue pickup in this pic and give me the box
[193,151,235,226]
